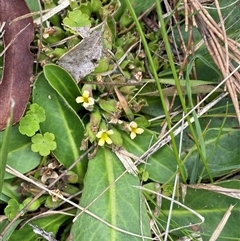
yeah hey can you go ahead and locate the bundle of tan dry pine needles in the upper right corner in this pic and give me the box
[185,0,240,124]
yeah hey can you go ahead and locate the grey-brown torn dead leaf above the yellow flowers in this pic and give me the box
[58,30,103,83]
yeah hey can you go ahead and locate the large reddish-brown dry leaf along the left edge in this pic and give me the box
[0,0,34,130]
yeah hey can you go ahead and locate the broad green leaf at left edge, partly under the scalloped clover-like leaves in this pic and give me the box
[0,125,41,179]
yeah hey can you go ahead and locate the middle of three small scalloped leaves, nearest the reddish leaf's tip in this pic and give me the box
[18,115,39,137]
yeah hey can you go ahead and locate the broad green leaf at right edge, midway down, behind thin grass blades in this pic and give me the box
[184,128,240,179]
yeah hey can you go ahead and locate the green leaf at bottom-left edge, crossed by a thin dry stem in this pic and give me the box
[9,213,69,241]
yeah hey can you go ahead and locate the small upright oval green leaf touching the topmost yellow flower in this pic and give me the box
[43,64,82,111]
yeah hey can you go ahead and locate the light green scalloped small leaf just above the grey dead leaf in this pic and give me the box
[63,10,91,27]
